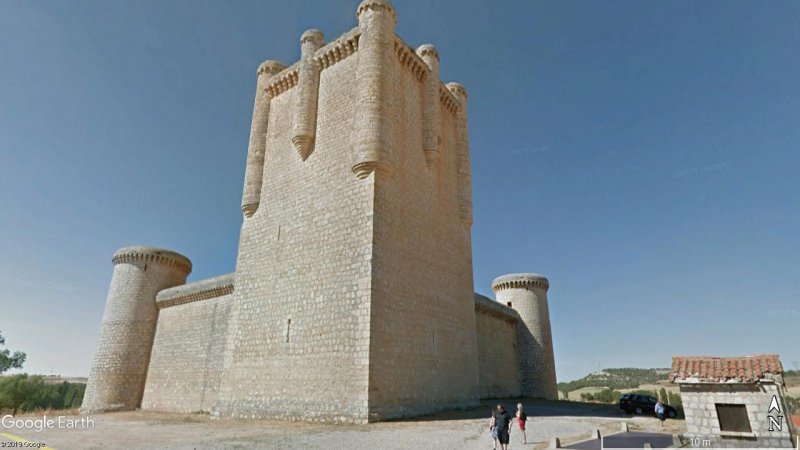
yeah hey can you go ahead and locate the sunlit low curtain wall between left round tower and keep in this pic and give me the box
[142,273,234,412]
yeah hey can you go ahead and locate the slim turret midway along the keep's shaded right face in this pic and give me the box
[417,44,440,167]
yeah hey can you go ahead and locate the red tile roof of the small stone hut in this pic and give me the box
[669,355,783,382]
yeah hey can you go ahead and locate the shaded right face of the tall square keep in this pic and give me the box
[369,37,479,419]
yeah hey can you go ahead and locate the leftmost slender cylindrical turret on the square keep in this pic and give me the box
[242,60,286,217]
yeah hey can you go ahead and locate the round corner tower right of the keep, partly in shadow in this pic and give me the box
[492,273,558,400]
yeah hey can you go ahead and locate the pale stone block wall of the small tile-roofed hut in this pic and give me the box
[680,383,795,448]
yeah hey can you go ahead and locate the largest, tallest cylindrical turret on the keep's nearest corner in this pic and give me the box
[352,0,397,178]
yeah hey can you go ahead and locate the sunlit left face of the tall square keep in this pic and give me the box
[212,42,373,422]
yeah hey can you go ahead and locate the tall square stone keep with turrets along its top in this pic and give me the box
[213,0,478,423]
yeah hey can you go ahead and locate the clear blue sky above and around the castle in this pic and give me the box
[0,0,800,381]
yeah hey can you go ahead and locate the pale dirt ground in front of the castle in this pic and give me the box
[0,400,683,450]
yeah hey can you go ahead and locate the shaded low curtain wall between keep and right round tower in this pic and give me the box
[475,294,520,398]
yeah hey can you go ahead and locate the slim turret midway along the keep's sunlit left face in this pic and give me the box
[292,30,324,161]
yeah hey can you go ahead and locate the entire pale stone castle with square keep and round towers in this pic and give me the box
[82,0,557,423]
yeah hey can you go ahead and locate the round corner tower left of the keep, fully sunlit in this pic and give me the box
[81,247,192,413]
